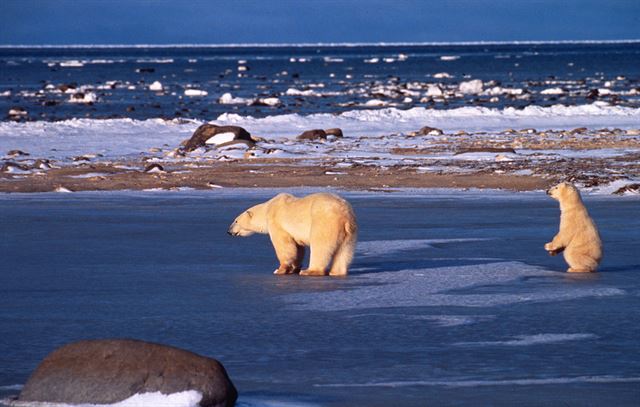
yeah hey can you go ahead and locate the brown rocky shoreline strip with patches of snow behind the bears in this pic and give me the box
[0,124,640,194]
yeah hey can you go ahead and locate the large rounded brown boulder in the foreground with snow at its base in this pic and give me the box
[18,339,238,407]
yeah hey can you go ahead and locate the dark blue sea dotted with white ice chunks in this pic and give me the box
[0,41,640,121]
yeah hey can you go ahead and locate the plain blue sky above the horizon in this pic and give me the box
[0,0,640,45]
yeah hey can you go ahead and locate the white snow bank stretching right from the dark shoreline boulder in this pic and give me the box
[215,102,640,137]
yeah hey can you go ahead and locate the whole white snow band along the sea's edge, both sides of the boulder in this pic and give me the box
[0,103,640,158]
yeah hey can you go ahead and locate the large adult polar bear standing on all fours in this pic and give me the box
[227,193,358,276]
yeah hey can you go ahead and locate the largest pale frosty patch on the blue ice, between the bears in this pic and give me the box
[284,262,625,311]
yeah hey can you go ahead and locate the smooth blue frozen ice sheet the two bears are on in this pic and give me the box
[0,192,640,407]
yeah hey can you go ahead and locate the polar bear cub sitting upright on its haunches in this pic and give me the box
[544,182,602,273]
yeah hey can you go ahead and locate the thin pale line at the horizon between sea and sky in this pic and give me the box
[0,38,640,49]
